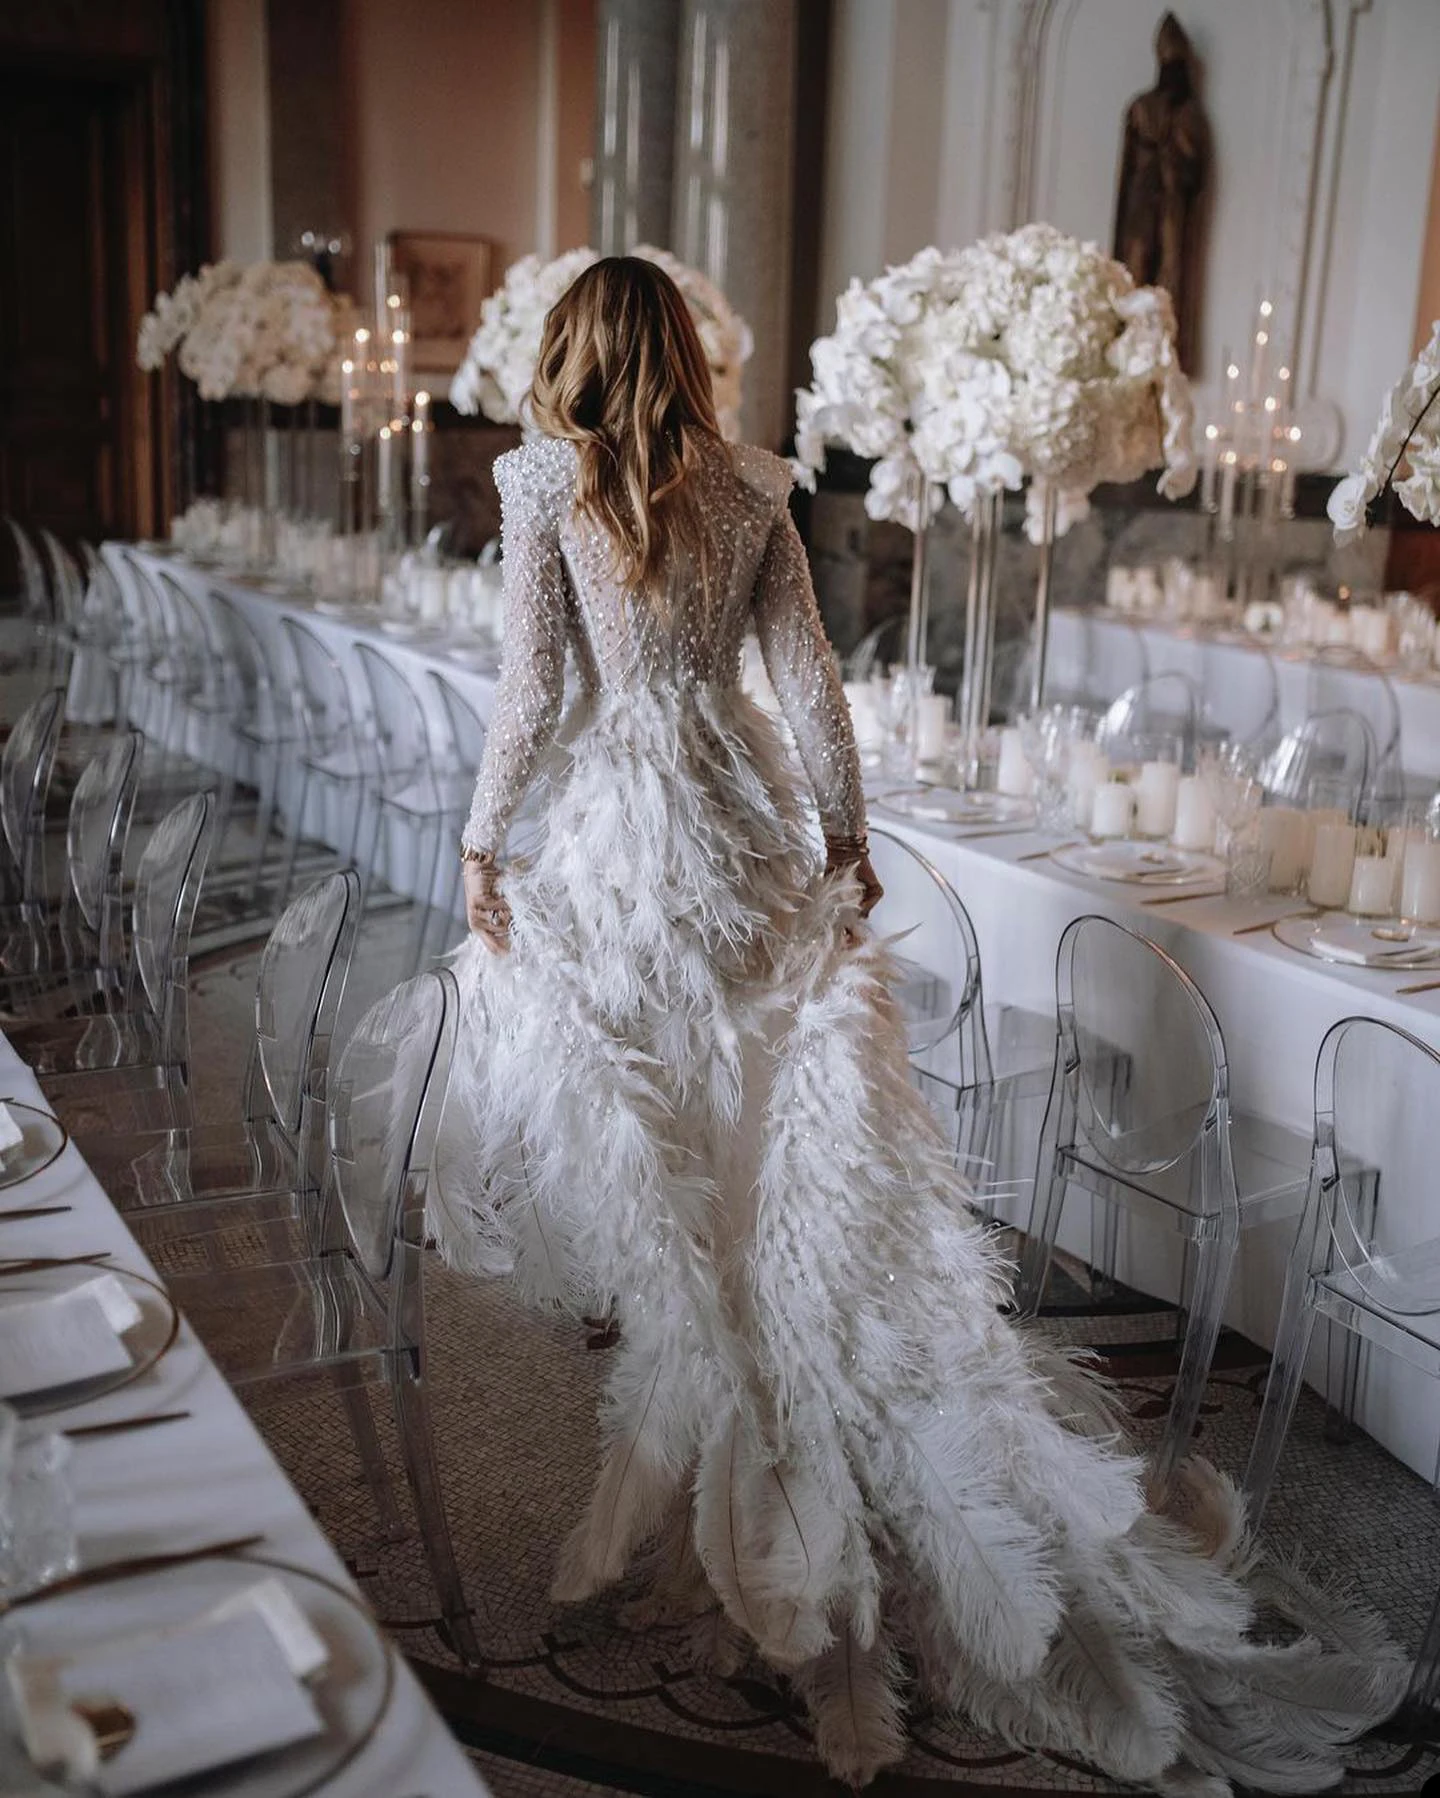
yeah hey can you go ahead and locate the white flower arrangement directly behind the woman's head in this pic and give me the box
[449,245,755,439]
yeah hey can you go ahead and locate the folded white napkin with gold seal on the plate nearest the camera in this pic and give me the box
[7,1577,329,1798]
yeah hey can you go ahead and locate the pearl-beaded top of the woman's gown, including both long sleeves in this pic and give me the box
[464,439,865,852]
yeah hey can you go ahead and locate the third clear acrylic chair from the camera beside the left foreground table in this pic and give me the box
[5,793,212,1124]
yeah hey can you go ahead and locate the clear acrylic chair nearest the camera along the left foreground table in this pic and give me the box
[160,969,480,1661]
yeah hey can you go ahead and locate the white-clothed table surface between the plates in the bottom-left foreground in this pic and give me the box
[0,1037,485,1798]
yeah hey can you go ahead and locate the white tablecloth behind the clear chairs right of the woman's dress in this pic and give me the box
[870,804,1440,1478]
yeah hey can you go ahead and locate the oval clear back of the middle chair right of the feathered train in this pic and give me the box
[1059,917,1224,1178]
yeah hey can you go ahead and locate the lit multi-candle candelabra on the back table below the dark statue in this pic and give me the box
[1201,300,1300,606]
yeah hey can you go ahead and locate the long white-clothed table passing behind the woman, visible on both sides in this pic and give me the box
[95,548,1440,1476]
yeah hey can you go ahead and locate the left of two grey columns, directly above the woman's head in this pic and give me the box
[590,0,681,255]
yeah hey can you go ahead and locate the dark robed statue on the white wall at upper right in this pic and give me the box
[1115,13,1210,370]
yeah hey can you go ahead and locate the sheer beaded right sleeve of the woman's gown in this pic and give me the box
[753,511,865,836]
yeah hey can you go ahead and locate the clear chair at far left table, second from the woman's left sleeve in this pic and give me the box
[354,644,475,967]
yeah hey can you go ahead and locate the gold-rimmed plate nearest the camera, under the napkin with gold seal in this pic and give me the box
[0,1553,396,1798]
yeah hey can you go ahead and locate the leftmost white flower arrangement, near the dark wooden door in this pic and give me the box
[137,263,351,406]
